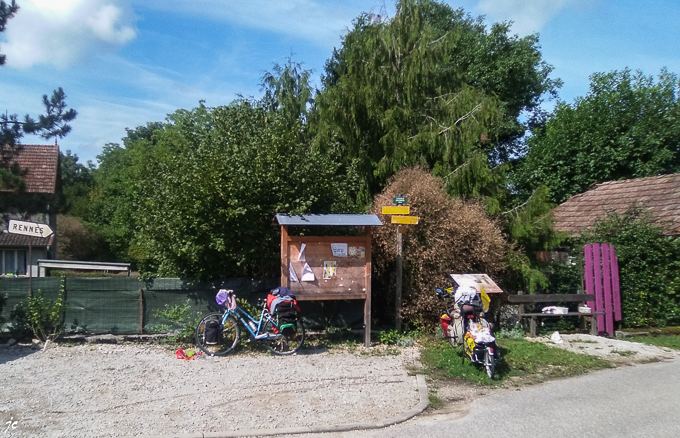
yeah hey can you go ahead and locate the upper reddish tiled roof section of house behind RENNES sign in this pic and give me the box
[0,144,59,193]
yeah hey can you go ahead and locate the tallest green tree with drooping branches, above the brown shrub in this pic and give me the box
[316,0,559,204]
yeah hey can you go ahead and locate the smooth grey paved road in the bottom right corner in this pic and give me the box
[294,360,680,438]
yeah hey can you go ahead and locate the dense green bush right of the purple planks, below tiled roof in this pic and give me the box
[580,208,680,327]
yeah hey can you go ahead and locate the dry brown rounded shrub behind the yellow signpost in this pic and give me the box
[371,168,507,326]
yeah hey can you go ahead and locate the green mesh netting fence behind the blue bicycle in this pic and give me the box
[0,277,363,334]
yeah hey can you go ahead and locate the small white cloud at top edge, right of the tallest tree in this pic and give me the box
[477,0,585,35]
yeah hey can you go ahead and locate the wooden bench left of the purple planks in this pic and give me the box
[508,294,604,337]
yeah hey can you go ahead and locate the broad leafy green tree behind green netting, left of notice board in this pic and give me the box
[88,61,354,278]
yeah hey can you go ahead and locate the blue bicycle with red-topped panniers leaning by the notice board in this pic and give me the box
[195,287,305,356]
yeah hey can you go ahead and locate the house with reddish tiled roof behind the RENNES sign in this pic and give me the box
[0,144,61,277]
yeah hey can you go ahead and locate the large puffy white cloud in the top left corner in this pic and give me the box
[2,0,136,68]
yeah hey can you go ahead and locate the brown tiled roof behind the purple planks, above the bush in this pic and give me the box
[553,174,680,236]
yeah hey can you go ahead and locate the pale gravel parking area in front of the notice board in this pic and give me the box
[0,344,418,437]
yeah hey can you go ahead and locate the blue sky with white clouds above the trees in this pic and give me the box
[0,0,680,162]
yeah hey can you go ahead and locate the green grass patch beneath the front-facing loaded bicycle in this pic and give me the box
[421,339,613,385]
